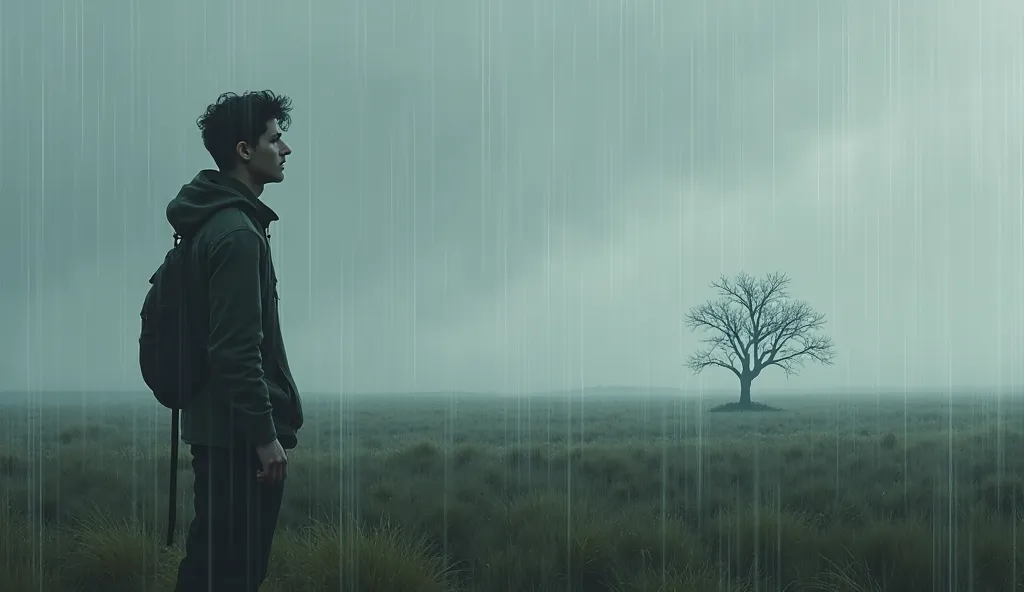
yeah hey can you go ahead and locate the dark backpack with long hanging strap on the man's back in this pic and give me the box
[138,234,207,546]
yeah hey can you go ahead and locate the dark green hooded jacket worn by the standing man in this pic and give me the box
[167,170,303,449]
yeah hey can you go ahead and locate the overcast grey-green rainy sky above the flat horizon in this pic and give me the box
[0,0,1024,391]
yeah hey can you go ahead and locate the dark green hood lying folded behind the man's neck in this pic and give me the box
[167,170,279,236]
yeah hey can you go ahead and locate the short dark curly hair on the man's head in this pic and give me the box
[196,90,292,170]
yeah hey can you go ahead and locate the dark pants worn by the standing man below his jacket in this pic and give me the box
[175,446,284,592]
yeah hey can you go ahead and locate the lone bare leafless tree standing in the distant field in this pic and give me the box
[686,273,836,406]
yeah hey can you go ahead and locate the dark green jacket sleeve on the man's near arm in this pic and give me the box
[208,224,278,446]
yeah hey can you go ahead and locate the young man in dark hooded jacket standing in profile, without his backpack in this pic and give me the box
[167,91,303,592]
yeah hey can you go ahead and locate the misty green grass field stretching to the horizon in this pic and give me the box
[0,387,1024,592]
